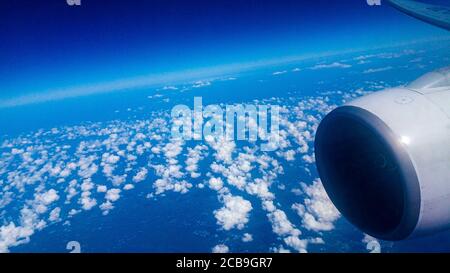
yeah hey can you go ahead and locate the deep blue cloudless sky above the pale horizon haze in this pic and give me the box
[0,0,447,98]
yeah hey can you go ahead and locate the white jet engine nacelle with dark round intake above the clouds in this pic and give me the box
[315,67,450,240]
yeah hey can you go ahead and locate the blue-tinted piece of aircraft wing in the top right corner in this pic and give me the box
[387,0,450,30]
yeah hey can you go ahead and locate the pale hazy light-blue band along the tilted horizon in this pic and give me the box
[0,36,450,109]
